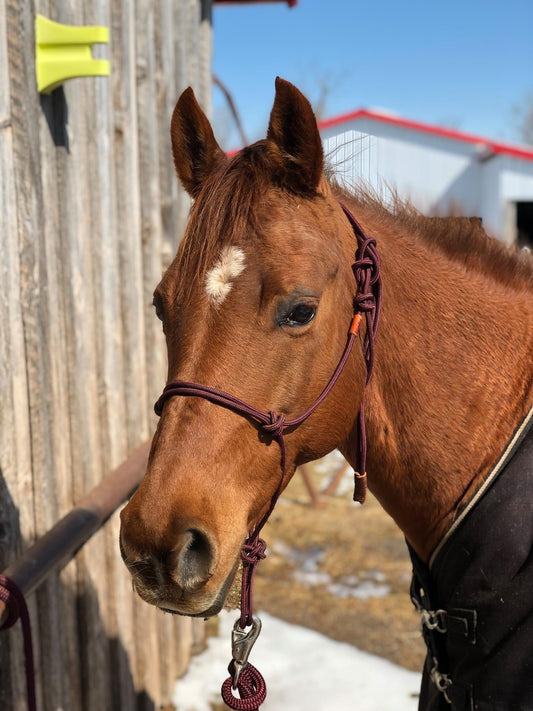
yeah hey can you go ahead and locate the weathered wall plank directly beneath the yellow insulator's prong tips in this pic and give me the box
[84,0,137,708]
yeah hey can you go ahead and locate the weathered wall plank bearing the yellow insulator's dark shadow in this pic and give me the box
[35,0,81,708]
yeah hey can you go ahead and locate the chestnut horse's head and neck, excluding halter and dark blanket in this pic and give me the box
[121,79,533,708]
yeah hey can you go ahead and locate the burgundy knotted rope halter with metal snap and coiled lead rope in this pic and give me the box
[154,203,382,711]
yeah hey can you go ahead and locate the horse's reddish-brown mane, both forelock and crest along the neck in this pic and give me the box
[176,140,533,292]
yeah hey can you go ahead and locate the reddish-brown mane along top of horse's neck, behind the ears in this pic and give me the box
[330,181,533,292]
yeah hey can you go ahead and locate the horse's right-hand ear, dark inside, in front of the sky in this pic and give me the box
[267,77,324,193]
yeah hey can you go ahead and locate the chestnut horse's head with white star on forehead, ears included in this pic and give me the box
[121,79,365,616]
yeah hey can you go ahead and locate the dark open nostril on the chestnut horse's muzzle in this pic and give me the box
[168,528,214,591]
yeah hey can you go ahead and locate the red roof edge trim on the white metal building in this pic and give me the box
[318,109,533,161]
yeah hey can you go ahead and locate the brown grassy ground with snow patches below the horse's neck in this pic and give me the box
[234,453,424,670]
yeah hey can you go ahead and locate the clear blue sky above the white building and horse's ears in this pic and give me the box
[213,0,533,148]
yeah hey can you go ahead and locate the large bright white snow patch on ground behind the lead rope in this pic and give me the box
[173,611,420,711]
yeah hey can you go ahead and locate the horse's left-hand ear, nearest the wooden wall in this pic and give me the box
[170,87,225,198]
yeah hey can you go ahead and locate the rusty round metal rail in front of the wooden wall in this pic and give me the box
[0,441,151,623]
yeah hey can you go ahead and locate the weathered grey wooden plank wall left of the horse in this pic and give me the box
[0,0,211,711]
